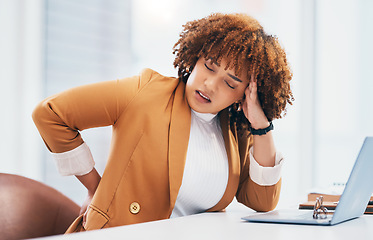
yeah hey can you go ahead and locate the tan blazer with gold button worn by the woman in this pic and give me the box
[33,69,281,232]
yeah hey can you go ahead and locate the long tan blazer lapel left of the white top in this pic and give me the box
[168,82,191,214]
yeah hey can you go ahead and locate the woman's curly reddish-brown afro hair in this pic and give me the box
[173,13,294,134]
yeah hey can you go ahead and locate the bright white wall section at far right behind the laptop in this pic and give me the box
[314,0,373,186]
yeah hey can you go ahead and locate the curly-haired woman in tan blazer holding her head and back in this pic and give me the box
[33,14,293,232]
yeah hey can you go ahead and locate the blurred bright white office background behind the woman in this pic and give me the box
[0,0,373,204]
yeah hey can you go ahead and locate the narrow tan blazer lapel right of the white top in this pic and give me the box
[208,109,240,212]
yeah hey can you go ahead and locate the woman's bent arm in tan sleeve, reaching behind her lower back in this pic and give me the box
[33,72,150,217]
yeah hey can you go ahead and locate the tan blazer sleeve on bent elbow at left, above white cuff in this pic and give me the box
[32,69,152,153]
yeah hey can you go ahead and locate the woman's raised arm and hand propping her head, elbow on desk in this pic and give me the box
[236,70,282,211]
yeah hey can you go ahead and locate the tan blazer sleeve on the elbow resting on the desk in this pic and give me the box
[236,136,281,212]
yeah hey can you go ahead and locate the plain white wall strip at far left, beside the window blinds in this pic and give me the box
[0,0,44,180]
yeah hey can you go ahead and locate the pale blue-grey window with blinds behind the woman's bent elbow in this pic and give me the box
[44,0,132,203]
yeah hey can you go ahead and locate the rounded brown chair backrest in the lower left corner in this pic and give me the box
[0,173,80,239]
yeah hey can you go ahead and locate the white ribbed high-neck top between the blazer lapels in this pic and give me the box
[171,110,229,218]
